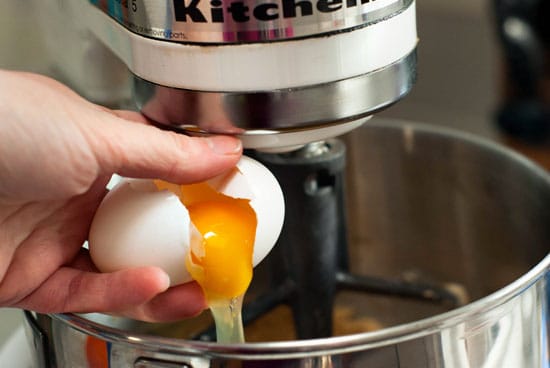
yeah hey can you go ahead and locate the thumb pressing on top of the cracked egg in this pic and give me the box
[88,111,242,183]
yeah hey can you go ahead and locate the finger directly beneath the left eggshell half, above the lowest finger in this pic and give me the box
[15,267,170,313]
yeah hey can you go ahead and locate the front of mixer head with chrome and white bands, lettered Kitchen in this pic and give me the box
[87,0,417,151]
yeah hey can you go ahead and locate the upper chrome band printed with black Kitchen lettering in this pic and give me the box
[89,0,413,44]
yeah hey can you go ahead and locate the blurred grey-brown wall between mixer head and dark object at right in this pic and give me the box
[380,0,501,138]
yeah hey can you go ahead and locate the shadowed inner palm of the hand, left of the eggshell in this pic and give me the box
[0,182,110,305]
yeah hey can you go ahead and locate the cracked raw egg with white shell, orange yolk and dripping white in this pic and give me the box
[88,156,284,342]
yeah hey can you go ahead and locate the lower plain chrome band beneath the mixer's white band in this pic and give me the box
[134,50,416,135]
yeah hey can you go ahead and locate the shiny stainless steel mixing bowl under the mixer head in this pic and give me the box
[25,122,550,368]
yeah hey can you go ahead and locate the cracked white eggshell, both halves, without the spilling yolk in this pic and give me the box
[88,156,284,285]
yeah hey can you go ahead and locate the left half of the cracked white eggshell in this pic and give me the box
[88,179,196,285]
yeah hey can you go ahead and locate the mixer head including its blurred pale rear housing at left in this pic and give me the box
[0,0,417,149]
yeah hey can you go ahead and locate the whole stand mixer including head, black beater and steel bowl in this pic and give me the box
[9,0,550,368]
